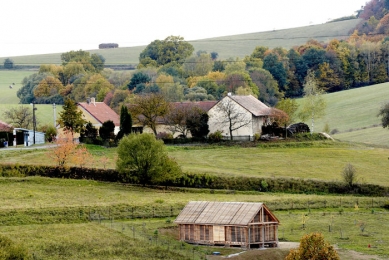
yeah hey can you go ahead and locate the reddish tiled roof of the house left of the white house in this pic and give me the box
[78,102,120,126]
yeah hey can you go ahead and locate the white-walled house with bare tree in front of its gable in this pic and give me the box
[208,94,271,140]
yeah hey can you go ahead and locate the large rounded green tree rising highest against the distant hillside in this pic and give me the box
[139,36,194,67]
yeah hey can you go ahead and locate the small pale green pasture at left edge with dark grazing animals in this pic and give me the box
[0,70,34,104]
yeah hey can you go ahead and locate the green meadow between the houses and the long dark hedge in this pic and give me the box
[0,141,389,186]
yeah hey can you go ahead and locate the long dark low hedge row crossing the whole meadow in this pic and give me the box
[0,164,389,196]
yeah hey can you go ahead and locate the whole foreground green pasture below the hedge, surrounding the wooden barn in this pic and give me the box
[0,177,389,259]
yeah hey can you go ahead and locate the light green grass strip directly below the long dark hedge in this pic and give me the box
[0,177,389,211]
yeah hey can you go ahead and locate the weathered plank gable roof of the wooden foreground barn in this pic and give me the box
[175,201,279,225]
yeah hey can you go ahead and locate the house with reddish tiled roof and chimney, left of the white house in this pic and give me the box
[77,98,120,135]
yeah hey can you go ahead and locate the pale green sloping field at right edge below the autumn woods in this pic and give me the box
[298,83,389,146]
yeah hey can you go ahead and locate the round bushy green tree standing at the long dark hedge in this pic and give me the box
[116,134,181,186]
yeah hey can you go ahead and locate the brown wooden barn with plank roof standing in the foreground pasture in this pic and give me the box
[175,201,279,248]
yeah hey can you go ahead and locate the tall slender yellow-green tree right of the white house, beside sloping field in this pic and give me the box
[299,71,327,133]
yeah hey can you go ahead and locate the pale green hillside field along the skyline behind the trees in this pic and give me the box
[0,19,361,65]
